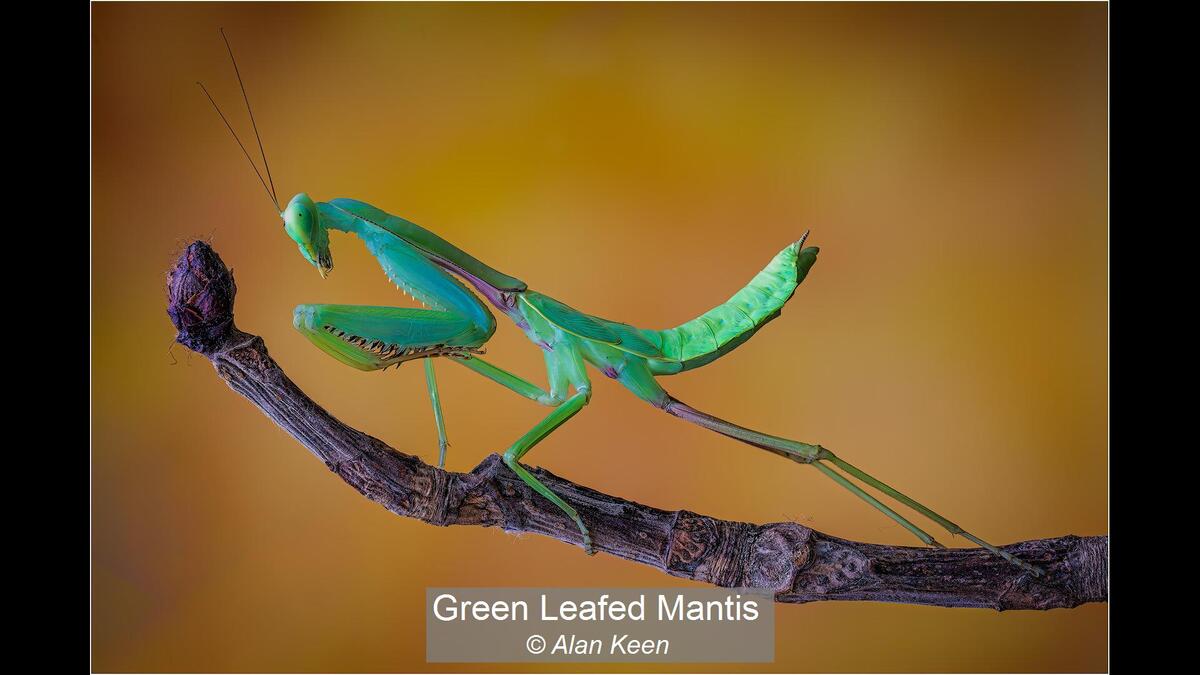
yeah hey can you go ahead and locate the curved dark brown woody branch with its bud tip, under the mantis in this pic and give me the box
[167,241,1108,610]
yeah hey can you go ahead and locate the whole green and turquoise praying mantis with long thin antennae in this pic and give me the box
[200,31,1043,575]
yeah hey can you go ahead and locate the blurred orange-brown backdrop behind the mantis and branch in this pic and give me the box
[91,4,1108,671]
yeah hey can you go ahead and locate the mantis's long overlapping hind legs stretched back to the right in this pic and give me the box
[618,368,1043,575]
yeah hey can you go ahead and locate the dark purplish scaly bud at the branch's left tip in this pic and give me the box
[167,241,238,354]
